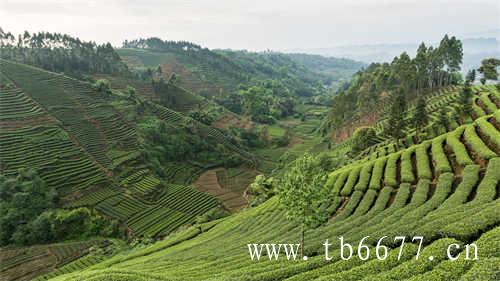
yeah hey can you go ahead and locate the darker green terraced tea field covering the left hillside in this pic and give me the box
[0,60,227,241]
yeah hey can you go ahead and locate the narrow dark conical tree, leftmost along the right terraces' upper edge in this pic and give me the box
[386,90,406,149]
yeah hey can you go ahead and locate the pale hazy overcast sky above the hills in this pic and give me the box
[0,0,500,50]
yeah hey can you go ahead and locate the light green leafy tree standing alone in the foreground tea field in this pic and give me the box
[278,153,328,255]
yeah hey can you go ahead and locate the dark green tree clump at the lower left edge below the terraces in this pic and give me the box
[0,169,120,246]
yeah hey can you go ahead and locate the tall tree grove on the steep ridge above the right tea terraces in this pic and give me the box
[327,35,463,131]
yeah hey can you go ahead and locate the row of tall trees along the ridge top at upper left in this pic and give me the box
[0,28,128,74]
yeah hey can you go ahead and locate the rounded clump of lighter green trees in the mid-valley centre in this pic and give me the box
[216,80,296,124]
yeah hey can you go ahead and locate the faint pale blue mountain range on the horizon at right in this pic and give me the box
[294,37,500,71]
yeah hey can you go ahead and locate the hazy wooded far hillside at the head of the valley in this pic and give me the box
[117,38,362,100]
